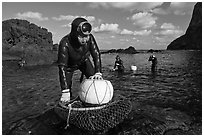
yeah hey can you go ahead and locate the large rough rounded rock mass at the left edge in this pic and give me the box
[2,19,56,65]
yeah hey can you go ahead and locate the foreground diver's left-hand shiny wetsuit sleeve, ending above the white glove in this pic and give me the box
[58,39,69,91]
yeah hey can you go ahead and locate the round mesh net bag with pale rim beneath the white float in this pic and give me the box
[55,95,132,131]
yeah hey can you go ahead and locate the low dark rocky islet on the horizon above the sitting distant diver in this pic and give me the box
[102,46,139,54]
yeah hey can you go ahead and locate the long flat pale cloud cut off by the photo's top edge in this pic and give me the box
[88,2,162,10]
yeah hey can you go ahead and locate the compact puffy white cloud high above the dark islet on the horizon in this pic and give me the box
[127,12,157,28]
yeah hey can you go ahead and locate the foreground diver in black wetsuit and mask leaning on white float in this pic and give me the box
[58,17,102,105]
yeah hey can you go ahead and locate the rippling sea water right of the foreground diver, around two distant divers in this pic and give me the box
[102,51,202,116]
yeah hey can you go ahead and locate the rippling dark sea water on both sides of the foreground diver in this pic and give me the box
[2,50,202,134]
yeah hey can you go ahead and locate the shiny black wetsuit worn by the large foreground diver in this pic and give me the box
[58,17,101,95]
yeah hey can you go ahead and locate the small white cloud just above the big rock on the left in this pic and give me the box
[16,11,48,21]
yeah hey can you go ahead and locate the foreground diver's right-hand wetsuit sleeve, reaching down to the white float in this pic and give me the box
[90,34,101,73]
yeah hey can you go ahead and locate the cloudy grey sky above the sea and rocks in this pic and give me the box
[2,2,195,50]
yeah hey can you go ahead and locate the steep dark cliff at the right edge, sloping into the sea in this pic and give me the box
[167,2,202,50]
